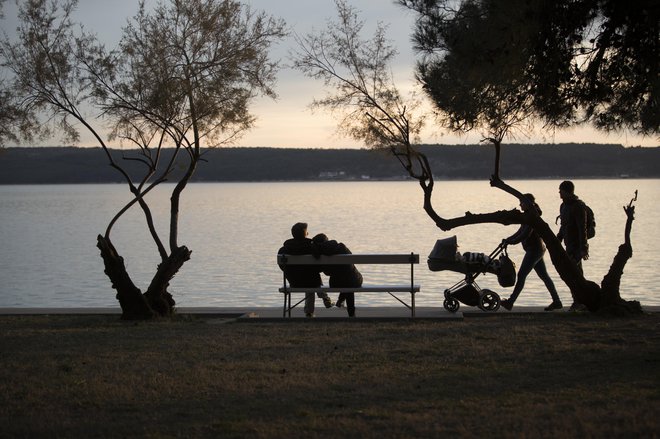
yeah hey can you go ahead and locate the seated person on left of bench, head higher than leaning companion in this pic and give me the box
[277,223,334,317]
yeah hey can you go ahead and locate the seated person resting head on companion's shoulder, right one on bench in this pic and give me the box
[312,233,362,317]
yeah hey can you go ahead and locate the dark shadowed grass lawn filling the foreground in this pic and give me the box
[0,313,660,438]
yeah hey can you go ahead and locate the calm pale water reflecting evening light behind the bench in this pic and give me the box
[0,180,660,307]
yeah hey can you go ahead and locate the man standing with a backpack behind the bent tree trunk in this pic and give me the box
[557,180,589,309]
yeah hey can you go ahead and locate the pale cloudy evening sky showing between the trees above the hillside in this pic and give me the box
[0,0,660,148]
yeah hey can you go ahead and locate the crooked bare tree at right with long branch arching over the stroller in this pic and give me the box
[293,0,640,312]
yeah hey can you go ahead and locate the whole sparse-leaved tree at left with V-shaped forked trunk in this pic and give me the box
[2,0,285,319]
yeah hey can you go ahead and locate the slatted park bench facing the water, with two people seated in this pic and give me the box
[277,253,420,318]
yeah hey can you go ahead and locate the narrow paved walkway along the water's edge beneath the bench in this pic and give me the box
[0,306,660,322]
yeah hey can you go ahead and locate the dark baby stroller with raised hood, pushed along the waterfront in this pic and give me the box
[428,236,516,312]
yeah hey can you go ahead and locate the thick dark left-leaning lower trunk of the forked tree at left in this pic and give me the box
[96,235,154,320]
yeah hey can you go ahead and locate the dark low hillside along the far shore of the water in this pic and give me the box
[0,144,660,184]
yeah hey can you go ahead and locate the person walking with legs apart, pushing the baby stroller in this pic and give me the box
[501,194,563,311]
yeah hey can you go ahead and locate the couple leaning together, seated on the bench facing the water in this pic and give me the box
[278,223,362,317]
